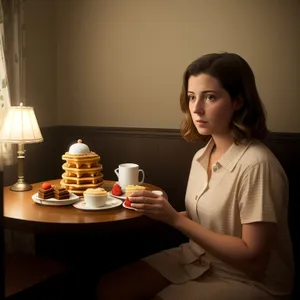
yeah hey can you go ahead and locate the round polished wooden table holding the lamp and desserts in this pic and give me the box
[4,179,165,233]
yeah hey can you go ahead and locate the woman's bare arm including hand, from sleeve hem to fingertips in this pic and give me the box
[130,191,277,278]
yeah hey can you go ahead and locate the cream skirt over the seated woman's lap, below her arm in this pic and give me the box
[143,248,288,300]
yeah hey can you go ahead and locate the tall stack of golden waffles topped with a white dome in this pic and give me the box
[60,140,103,196]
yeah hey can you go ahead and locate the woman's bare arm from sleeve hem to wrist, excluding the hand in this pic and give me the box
[170,213,277,278]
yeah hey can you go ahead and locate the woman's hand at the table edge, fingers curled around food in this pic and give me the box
[129,190,179,226]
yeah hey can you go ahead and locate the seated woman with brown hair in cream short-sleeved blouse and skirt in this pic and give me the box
[99,53,293,300]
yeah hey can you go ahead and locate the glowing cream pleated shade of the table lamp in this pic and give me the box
[0,103,43,144]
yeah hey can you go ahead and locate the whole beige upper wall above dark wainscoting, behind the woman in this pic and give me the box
[27,0,300,132]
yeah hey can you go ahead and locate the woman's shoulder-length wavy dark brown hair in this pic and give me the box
[180,53,268,144]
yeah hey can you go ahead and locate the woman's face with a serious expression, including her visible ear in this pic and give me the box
[188,74,240,136]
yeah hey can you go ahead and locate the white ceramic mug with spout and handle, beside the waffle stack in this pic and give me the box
[115,163,145,191]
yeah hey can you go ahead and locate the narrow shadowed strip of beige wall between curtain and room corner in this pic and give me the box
[24,0,57,126]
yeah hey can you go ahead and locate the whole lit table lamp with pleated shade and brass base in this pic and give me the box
[0,103,43,192]
